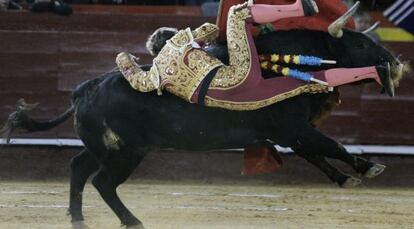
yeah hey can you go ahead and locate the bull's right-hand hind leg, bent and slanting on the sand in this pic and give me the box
[92,152,143,228]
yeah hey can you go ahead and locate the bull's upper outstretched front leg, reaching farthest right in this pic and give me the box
[298,124,385,178]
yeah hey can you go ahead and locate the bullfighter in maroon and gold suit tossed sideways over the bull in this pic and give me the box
[116,0,394,110]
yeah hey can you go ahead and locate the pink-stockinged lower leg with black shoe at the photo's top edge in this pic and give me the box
[250,0,318,24]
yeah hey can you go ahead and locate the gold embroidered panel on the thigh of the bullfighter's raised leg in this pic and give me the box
[210,6,251,90]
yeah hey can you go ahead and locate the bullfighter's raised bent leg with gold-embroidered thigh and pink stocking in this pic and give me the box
[209,0,317,91]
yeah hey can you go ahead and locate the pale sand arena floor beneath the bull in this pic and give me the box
[0,180,414,229]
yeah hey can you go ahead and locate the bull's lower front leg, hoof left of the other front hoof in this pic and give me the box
[292,143,361,188]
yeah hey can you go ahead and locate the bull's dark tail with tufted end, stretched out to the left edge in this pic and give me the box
[0,99,75,143]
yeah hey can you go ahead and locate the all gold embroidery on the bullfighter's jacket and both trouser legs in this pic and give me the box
[117,3,328,110]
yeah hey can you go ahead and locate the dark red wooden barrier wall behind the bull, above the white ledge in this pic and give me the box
[0,7,414,144]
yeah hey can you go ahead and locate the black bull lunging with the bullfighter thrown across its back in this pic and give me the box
[3,30,399,226]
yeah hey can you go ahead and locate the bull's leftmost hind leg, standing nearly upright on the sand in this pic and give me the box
[68,149,99,222]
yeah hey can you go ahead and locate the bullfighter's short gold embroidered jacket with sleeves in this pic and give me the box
[116,23,223,101]
